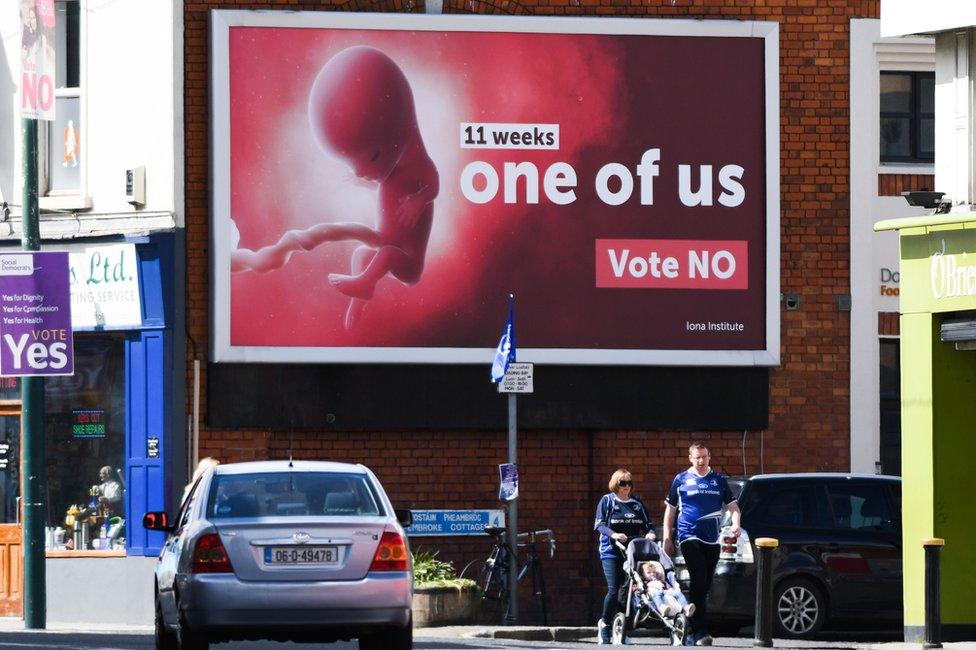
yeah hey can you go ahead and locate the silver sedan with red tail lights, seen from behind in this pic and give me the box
[143,461,413,650]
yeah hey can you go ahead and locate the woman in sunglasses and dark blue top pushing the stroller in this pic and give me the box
[593,469,654,645]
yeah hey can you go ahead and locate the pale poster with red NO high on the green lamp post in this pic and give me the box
[19,0,56,120]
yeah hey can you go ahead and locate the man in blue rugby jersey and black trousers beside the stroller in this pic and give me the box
[664,440,740,645]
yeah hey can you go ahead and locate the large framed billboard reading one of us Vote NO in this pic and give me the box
[211,11,779,365]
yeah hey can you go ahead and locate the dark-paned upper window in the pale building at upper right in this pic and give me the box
[881,72,935,164]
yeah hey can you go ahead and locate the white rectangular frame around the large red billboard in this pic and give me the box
[209,9,780,366]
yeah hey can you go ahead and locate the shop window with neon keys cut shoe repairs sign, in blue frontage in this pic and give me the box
[44,334,126,551]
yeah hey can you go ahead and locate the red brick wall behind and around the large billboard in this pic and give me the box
[184,0,879,624]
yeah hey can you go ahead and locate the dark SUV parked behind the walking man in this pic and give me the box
[679,474,902,638]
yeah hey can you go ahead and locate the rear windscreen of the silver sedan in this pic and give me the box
[207,472,383,519]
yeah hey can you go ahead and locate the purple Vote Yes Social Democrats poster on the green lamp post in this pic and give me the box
[0,251,74,377]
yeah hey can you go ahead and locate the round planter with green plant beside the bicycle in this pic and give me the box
[412,549,481,627]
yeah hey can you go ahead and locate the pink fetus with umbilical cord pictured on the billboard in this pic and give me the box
[231,46,438,329]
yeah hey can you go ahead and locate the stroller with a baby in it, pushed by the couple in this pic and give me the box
[610,539,694,645]
